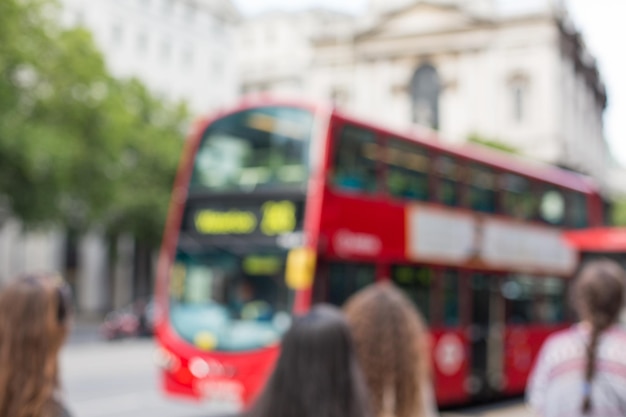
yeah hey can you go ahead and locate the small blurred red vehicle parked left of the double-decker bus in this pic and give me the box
[100,299,154,340]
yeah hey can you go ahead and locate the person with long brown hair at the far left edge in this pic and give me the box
[0,275,70,417]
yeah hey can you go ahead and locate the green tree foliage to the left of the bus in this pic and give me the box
[0,0,187,243]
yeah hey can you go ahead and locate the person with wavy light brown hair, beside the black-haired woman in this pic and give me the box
[344,283,437,417]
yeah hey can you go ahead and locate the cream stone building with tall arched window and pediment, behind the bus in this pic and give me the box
[302,1,606,188]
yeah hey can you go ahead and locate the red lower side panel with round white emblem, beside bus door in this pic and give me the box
[431,329,470,405]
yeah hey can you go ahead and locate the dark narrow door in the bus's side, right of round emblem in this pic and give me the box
[467,272,504,399]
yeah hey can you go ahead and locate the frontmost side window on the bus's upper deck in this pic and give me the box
[333,126,378,192]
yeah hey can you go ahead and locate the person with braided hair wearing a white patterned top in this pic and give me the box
[526,259,626,417]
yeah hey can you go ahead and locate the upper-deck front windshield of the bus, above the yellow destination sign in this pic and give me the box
[191,107,313,191]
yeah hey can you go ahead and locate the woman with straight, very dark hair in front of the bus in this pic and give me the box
[244,305,369,417]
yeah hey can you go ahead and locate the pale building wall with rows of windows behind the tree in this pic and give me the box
[63,0,238,114]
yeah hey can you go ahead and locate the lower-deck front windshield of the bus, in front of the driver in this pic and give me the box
[170,251,292,351]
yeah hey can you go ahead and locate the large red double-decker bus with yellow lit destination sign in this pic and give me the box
[157,99,602,405]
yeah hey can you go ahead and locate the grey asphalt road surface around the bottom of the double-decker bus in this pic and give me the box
[61,329,528,417]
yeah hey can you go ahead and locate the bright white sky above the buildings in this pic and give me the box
[234,0,626,166]
